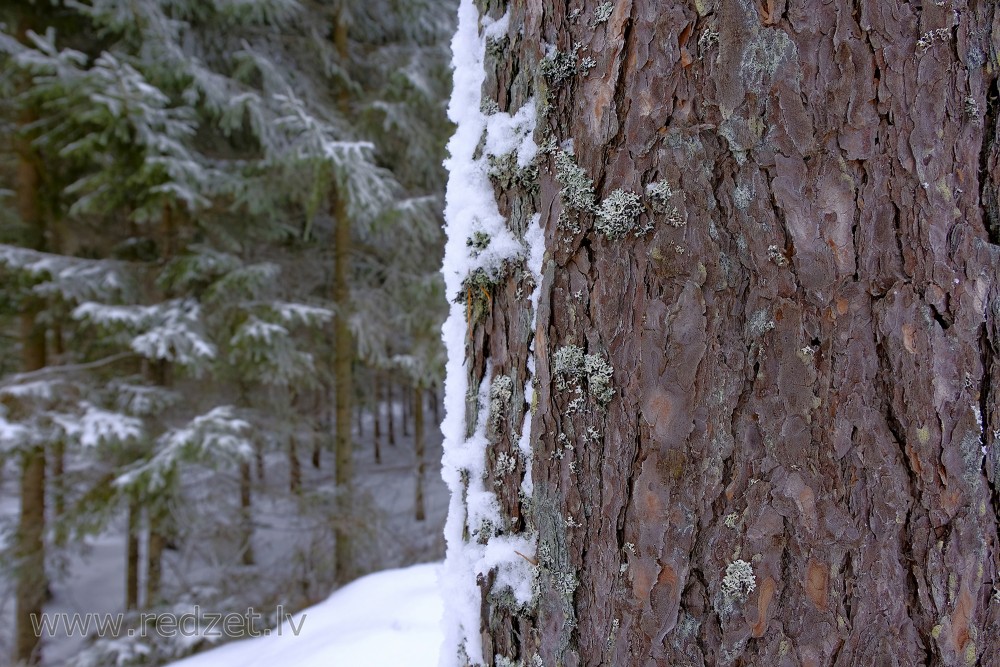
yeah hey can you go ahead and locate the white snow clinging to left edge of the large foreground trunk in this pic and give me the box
[441,0,545,667]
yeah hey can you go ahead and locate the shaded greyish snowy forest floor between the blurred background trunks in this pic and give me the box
[0,405,448,667]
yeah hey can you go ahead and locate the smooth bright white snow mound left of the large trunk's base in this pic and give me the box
[170,563,443,667]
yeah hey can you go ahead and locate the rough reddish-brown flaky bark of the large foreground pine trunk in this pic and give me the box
[468,0,1000,665]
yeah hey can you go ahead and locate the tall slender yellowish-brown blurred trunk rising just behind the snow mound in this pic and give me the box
[332,185,354,582]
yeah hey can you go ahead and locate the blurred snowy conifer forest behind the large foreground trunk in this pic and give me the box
[0,0,456,666]
